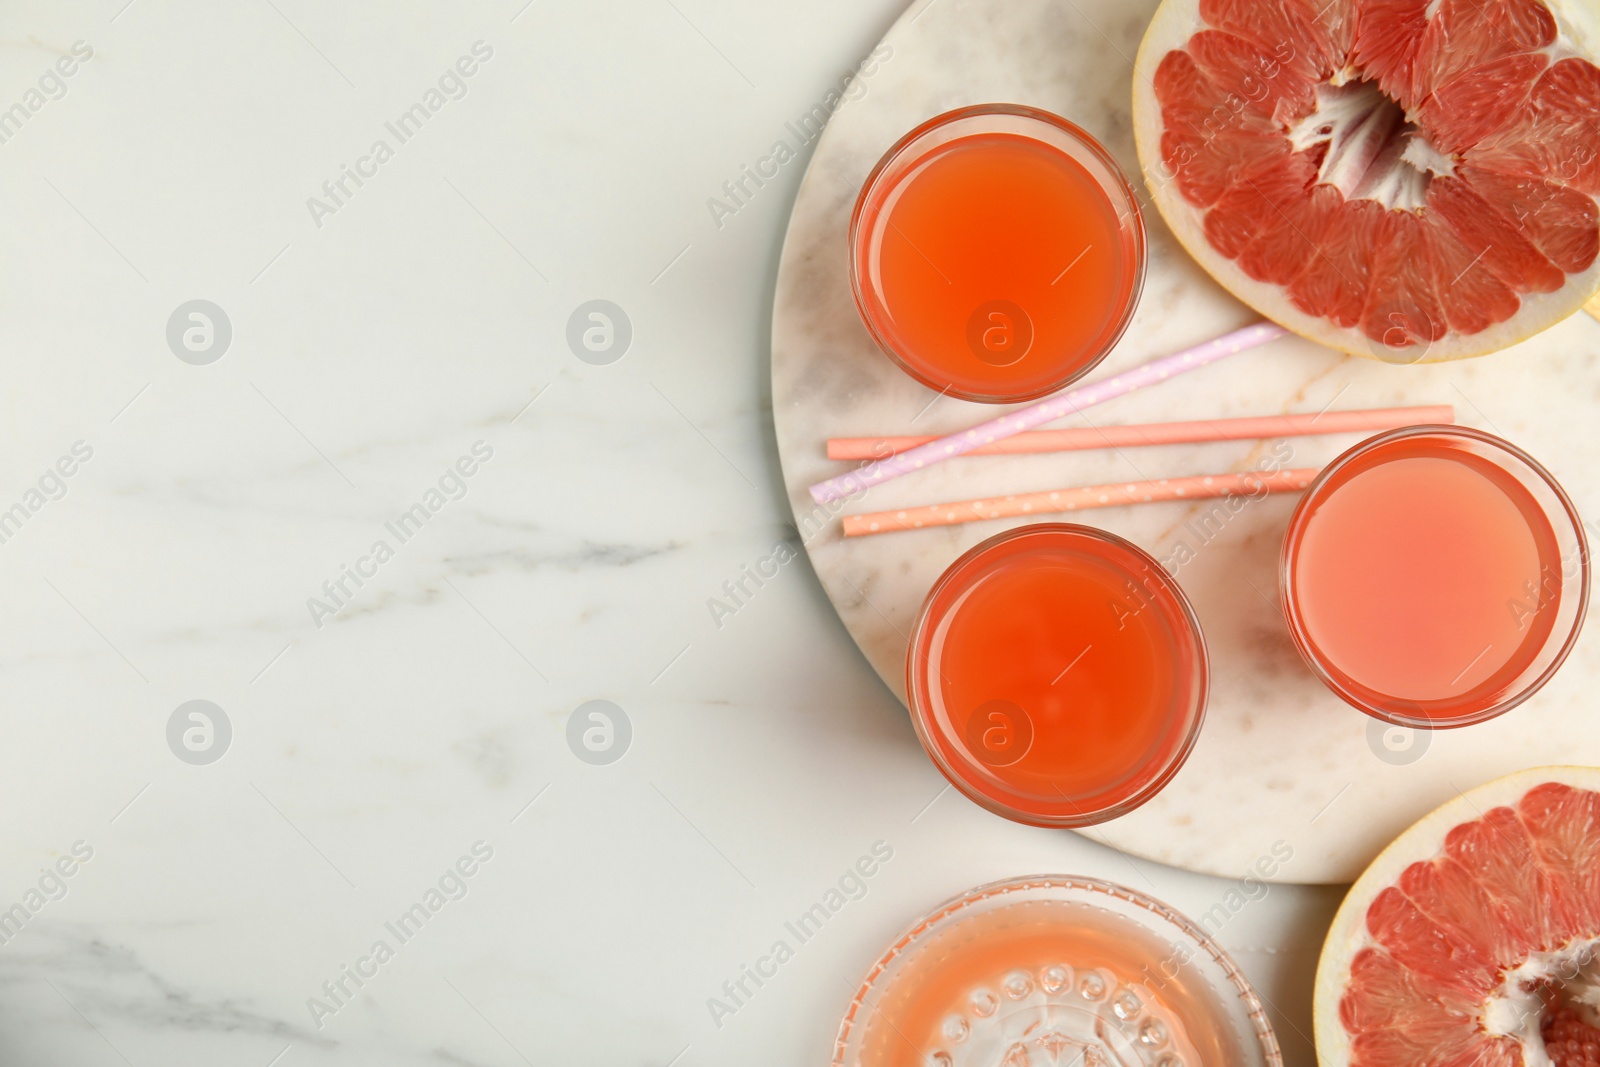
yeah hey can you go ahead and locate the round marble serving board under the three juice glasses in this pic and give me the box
[773,0,1600,883]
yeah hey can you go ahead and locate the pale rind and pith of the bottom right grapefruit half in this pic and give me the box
[1312,766,1600,1067]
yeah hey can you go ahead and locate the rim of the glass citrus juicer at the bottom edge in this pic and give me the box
[832,873,1283,1067]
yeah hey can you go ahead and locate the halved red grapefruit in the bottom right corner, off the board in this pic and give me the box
[1315,766,1600,1067]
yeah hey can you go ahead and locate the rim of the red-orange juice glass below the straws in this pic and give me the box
[906,523,1211,830]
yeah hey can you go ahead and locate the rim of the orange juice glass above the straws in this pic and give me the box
[848,102,1149,403]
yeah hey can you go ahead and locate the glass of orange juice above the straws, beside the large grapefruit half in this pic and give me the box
[850,104,1146,403]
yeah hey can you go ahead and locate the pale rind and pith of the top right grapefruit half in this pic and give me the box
[1133,0,1600,365]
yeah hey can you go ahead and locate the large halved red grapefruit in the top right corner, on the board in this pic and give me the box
[1133,0,1600,363]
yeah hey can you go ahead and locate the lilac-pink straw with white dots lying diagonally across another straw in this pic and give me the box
[811,322,1288,504]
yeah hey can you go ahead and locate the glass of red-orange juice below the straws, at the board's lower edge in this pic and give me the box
[906,523,1210,827]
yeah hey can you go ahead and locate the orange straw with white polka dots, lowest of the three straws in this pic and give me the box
[845,467,1318,537]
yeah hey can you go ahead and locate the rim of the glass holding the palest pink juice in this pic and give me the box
[1278,422,1589,729]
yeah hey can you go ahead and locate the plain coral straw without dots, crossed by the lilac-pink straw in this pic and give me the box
[827,405,1456,459]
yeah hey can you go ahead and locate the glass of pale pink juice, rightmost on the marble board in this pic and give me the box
[1280,426,1589,728]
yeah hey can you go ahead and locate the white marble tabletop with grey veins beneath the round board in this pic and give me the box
[0,0,1338,1067]
